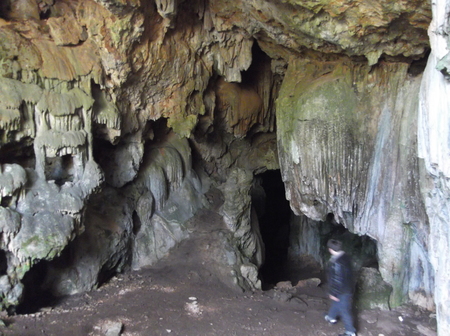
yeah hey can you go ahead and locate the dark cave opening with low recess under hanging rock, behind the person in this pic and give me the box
[252,170,378,290]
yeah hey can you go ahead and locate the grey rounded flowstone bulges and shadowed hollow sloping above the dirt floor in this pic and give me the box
[43,135,205,296]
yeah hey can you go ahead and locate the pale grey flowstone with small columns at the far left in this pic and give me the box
[0,77,103,308]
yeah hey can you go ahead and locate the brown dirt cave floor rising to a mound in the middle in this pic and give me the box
[0,200,436,336]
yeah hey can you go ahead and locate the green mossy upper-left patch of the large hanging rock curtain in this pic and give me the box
[277,61,362,156]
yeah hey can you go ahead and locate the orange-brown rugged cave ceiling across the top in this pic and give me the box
[0,0,431,141]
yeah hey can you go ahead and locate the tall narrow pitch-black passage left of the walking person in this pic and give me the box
[254,170,292,289]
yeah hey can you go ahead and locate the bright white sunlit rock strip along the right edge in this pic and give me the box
[418,0,450,335]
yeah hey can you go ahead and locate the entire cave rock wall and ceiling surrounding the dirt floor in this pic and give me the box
[0,0,450,335]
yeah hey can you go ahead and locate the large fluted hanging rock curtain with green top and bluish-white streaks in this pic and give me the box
[277,58,434,308]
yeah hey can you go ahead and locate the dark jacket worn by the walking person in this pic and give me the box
[328,253,354,297]
